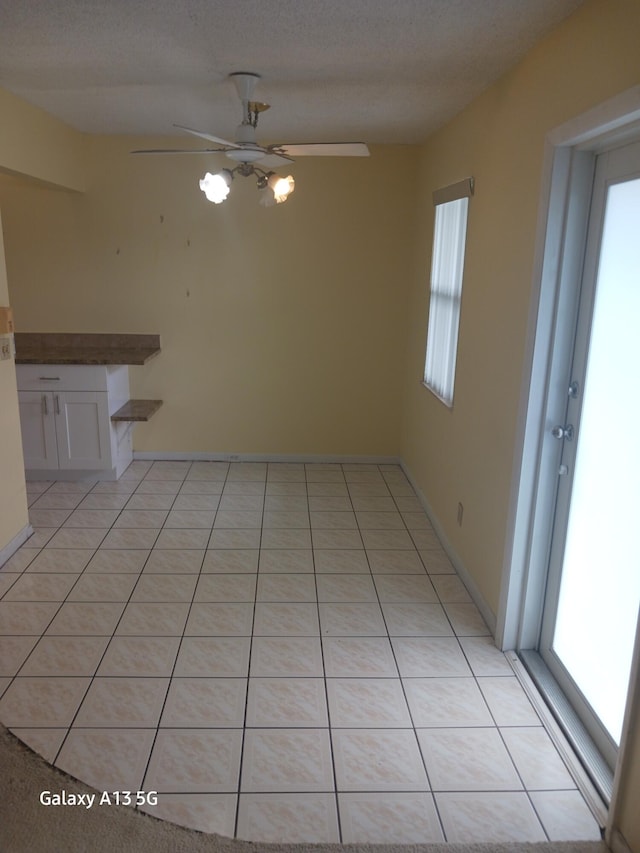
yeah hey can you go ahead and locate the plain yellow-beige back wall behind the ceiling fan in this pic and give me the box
[2,137,417,456]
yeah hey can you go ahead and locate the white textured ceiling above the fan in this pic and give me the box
[0,0,582,143]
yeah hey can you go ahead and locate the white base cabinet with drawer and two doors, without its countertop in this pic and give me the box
[16,364,132,479]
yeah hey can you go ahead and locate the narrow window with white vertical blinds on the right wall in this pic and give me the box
[424,178,473,406]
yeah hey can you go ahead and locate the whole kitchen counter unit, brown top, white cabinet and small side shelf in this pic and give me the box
[15,332,162,480]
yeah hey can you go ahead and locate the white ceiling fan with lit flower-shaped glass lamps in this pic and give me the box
[131,71,369,204]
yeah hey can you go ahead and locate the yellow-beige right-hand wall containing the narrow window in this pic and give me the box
[401,0,640,851]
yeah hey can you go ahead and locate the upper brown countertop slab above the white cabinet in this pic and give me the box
[15,332,160,364]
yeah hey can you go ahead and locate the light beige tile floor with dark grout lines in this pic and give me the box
[0,461,599,843]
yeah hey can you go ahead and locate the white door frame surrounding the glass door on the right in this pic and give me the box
[496,86,640,825]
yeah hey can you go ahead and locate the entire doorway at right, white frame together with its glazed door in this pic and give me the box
[497,99,640,802]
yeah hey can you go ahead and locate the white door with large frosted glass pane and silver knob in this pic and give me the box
[539,143,640,766]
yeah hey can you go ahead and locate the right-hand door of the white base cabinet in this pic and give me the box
[53,391,111,470]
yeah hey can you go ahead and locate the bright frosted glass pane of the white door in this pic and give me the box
[553,179,640,744]
